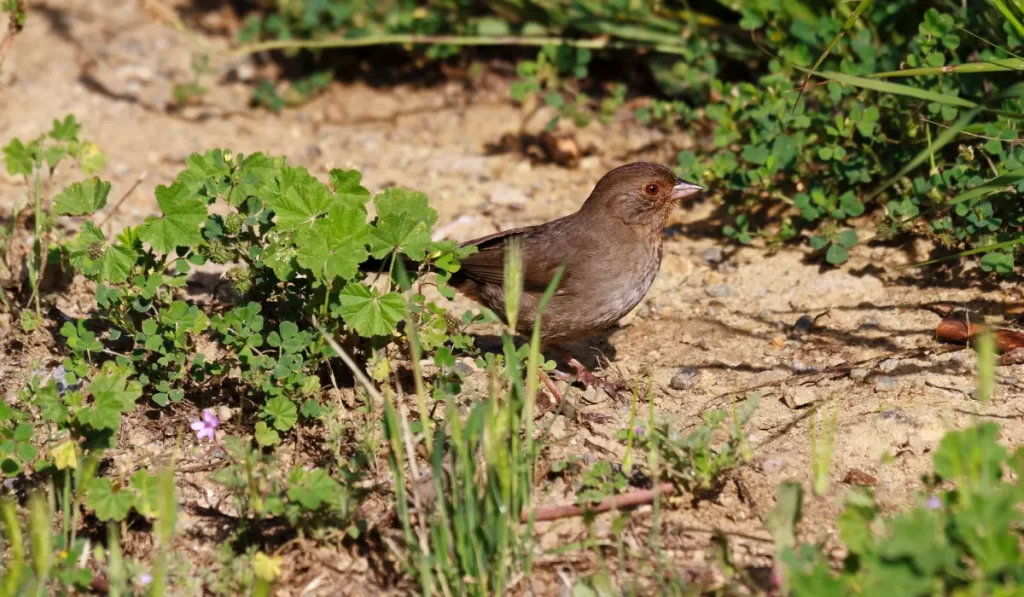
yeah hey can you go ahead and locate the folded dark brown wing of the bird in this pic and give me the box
[459,222,572,292]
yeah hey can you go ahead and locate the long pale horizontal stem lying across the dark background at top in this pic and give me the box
[231,34,684,56]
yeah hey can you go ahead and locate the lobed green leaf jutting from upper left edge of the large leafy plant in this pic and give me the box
[139,182,207,253]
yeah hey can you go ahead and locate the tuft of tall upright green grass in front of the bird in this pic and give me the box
[364,237,561,595]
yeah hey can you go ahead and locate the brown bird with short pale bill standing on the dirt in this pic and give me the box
[450,162,702,399]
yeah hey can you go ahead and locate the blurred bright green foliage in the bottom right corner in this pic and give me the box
[780,423,1024,596]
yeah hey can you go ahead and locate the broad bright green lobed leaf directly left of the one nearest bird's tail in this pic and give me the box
[295,208,369,280]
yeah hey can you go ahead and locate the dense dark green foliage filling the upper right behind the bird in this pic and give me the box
[237,0,1024,273]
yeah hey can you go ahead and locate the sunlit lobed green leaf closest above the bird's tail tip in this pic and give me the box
[370,188,437,261]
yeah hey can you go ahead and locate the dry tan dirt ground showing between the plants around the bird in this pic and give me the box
[0,0,1024,595]
